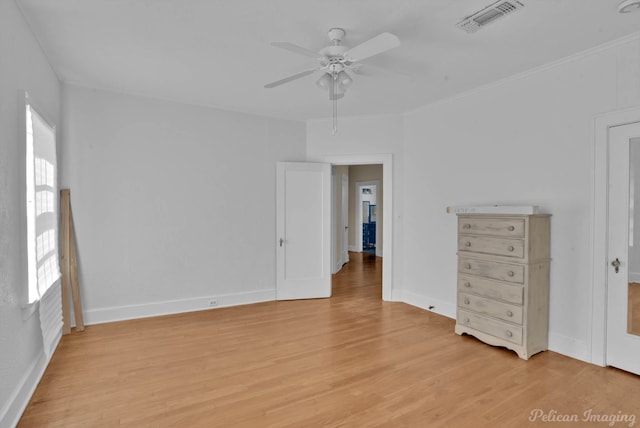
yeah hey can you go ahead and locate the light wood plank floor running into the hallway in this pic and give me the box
[19,253,640,428]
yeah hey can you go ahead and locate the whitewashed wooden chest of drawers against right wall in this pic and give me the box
[455,214,550,360]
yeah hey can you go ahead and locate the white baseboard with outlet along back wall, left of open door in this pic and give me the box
[79,289,276,325]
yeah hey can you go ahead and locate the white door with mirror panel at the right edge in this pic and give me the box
[606,123,640,374]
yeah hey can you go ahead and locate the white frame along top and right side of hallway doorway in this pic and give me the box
[307,154,392,301]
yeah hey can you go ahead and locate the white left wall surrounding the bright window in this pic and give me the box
[0,1,61,427]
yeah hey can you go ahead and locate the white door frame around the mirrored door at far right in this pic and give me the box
[590,108,640,366]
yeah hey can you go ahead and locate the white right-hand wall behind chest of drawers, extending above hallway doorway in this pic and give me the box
[307,36,640,360]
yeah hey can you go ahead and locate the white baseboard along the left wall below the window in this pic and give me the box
[0,330,62,428]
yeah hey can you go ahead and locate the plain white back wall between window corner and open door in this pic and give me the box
[62,86,305,323]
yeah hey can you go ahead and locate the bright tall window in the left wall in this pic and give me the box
[25,97,60,303]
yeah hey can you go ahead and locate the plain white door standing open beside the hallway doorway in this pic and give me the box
[276,162,331,300]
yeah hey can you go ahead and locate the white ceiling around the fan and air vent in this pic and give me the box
[15,0,640,120]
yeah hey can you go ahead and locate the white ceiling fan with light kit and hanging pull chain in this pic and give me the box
[264,28,400,134]
